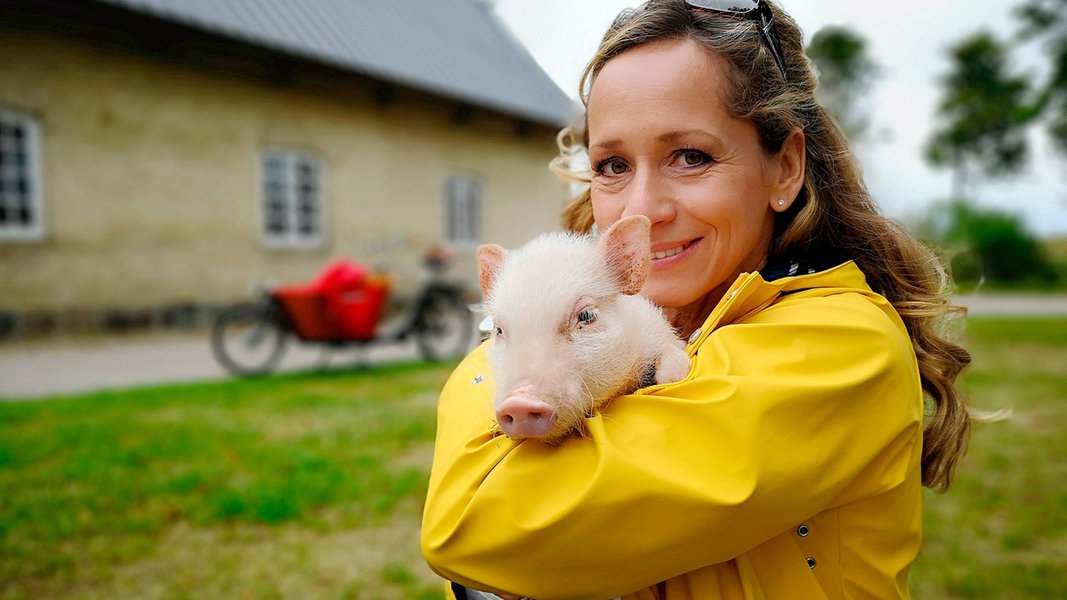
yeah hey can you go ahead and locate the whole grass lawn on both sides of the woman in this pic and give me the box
[0,318,1067,600]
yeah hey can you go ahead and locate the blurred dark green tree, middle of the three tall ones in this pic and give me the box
[926,32,1032,199]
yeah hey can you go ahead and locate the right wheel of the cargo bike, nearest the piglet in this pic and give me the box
[415,293,474,361]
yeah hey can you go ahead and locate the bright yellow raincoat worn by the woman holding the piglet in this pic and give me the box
[421,263,923,600]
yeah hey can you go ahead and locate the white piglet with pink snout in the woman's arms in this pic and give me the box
[477,216,689,445]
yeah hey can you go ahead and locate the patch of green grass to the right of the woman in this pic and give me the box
[912,318,1067,600]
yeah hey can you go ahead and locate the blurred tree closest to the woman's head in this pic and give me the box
[807,26,878,140]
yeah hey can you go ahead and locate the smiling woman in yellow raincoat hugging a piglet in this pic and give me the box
[423,0,970,600]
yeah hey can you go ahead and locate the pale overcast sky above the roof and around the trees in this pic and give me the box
[492,0,1067,237]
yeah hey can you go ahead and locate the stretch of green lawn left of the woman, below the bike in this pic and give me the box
[0,358,450,599]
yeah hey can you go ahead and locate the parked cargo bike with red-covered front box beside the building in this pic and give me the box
[211,254,475,377]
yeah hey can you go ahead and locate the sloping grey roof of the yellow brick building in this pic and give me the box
[90,0,577,126]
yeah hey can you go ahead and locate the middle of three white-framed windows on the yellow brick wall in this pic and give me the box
[262,149,324,248]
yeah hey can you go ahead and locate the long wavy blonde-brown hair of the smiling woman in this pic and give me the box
[552,0,971,490]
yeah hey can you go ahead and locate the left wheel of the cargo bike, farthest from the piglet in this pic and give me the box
[211,303,288,377]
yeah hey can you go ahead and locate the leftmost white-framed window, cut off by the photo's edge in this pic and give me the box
[0,108,45,241]
